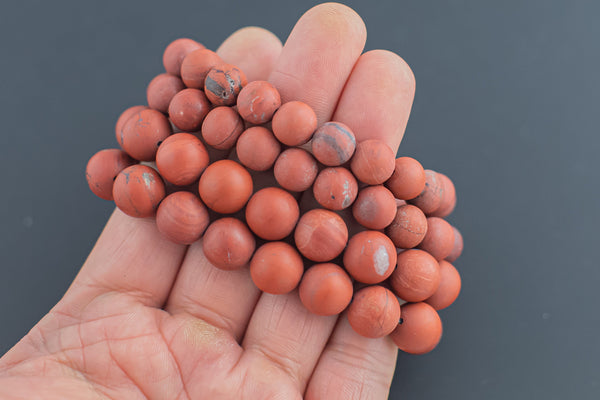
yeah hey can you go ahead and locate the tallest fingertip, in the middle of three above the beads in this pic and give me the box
[269,3,367,125]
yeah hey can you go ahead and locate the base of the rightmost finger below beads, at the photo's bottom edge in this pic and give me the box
[304,315,398,400]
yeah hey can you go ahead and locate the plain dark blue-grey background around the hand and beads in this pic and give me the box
[0,0,600,399]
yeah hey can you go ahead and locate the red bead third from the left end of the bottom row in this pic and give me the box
[156,191,210,244]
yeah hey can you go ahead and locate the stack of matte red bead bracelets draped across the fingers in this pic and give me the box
[86,39,463,354]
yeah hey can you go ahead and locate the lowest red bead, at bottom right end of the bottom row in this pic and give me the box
[390,303,442,354]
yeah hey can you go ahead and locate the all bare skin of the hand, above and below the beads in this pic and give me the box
[0,3,415,400]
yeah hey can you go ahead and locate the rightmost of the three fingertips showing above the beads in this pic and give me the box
[333,50,415,152]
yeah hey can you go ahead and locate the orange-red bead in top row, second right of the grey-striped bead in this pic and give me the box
[385,157,425,200]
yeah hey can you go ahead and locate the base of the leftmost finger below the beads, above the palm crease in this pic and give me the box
[62,209,187,314]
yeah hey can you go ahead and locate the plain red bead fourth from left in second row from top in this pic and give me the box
[236,126,281,171]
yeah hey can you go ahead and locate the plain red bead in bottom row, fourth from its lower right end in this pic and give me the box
[250,242,304,294]
